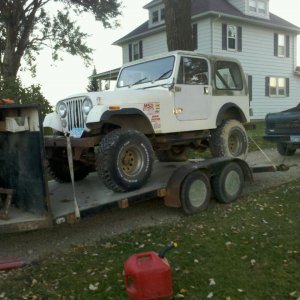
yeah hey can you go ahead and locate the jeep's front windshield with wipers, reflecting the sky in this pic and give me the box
[117,56,175,88]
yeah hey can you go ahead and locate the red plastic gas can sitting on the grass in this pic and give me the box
[124,252,173,300]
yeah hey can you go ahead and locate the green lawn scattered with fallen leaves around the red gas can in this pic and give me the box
[0,180,300,300]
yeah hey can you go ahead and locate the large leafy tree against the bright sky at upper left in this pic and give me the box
[0,0,121,80]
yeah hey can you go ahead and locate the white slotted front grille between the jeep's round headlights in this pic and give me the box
[64,97,85,131]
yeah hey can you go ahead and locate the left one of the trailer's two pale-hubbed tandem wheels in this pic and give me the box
[180,171,211,214]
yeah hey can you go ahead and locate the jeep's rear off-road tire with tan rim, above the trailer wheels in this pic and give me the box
[210,120,248,157]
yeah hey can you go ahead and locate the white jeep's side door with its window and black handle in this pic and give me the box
[174,57,212,121]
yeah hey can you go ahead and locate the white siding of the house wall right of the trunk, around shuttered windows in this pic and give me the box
[213,19,300,119]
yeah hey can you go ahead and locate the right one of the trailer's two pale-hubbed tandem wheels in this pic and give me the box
[212,162,244,203]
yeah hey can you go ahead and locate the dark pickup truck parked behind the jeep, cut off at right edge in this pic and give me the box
[264,103,300,156]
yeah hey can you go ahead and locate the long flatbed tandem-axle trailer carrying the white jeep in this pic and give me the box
[0,105,288,233]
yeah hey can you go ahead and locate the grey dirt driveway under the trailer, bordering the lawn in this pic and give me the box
[0,149,300,260]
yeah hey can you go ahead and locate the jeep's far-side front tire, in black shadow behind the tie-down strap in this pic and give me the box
[47,158,91,183]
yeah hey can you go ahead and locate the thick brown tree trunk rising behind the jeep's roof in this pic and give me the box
[163,0,193,51]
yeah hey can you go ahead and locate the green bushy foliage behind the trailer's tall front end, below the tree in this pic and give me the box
[0,78,53,117]
